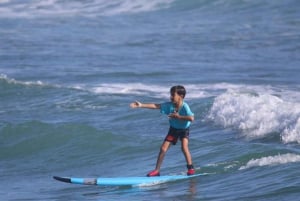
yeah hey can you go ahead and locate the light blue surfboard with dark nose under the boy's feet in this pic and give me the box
[53,173,206,186]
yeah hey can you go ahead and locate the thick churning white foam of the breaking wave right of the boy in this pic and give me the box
[207,90,300,143]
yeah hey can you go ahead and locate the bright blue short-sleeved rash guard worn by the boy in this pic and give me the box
[160,102,194,129]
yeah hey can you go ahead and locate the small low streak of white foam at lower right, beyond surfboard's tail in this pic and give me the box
[239,153,300,170]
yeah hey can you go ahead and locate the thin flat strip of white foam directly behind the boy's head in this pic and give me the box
[88,83,300,102]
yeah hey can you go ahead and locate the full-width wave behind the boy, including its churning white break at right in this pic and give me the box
[0,74,300,144]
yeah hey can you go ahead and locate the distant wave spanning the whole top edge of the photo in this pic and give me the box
[0,0,299,18]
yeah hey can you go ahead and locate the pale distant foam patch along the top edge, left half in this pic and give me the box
[0,0,174,17]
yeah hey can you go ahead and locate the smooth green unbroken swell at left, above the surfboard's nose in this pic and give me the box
[0,121,120,160]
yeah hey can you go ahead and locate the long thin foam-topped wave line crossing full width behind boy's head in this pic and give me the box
[0,74,300,100]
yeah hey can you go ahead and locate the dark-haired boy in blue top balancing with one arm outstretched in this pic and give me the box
[130,85,195,177]
